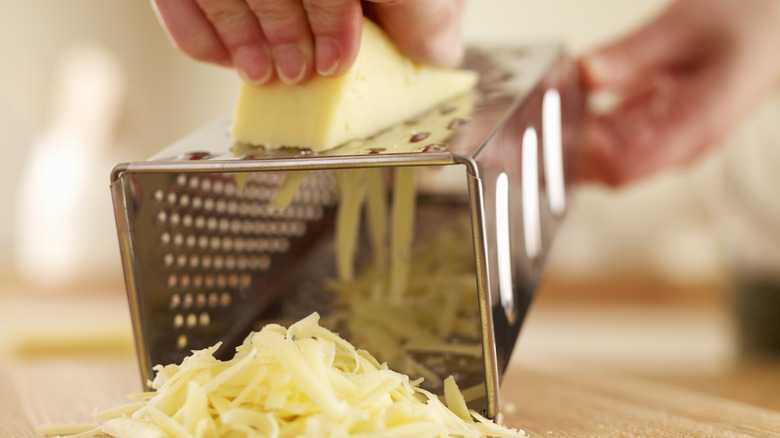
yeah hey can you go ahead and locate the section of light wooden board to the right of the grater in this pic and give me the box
[502,362,780,438]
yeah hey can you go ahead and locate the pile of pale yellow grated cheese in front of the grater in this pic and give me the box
[39,313,526,438]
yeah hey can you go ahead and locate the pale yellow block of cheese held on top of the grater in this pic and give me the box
[231,19,477,152]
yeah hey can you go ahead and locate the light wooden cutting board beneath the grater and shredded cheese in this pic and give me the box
[0,354,780,438]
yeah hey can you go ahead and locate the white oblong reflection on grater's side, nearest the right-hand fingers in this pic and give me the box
[542,88,566,216]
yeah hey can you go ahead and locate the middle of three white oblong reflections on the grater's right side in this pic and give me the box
[522,128,542,260]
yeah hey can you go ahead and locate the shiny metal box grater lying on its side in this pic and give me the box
[111,45,582,418]
